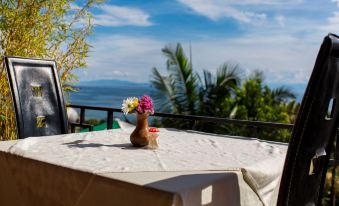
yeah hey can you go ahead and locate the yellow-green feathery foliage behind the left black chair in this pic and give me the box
[0,0,98,140]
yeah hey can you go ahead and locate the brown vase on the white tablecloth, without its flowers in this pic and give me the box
[130,113,149,147]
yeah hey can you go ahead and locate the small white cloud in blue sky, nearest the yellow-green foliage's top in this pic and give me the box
[94,4,152,27]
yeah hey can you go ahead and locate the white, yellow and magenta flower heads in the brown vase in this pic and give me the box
[121,95,154,115]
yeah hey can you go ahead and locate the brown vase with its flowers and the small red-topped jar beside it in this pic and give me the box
[121,95,159,149]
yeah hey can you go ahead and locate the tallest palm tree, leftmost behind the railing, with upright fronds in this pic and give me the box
[151,43,199,114]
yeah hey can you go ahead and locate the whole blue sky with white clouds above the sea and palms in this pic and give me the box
[73,0,339,85]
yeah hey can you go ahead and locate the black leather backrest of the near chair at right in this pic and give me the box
[277,34,339,206]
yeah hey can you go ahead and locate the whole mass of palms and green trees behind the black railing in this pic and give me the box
[151,43,299,141]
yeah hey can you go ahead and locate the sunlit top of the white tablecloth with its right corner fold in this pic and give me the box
[0,128,287,205]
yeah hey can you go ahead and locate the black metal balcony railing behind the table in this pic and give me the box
[67,104,339,205]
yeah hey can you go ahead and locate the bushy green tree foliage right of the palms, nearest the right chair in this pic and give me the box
[233,71,299,142]
